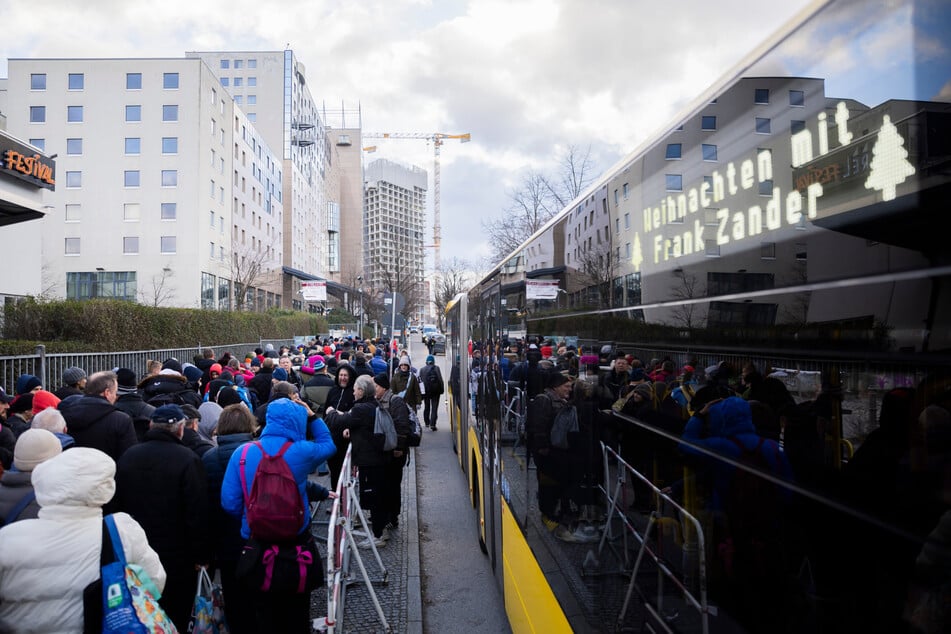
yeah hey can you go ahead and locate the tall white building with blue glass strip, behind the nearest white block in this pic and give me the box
[186,49,340,308]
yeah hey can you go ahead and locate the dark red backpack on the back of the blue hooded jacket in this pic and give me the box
[239,440,304,542]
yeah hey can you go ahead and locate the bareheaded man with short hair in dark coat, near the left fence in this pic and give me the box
[59,371,136,462]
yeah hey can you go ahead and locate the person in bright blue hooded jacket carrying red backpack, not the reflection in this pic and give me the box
[221,393,336,633]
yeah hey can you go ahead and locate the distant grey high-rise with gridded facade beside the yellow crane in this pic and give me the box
[363,154,429,320]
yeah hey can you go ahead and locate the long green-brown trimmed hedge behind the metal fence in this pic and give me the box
[0,299,327,355]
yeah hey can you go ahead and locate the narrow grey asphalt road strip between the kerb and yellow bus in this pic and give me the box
[410,335,511,634]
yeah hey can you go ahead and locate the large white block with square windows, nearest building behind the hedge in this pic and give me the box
[6,58,283,309]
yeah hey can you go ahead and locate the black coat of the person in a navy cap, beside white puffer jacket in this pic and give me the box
[116,429,211,576]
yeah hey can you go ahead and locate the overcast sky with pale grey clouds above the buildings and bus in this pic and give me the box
[0,0,810,270]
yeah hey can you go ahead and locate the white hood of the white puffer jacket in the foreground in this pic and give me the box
[32,447,116,508]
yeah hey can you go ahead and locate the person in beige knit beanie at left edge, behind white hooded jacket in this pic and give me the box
[0,429,63,525]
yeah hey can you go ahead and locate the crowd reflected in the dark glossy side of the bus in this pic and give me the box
[464,339,951,631]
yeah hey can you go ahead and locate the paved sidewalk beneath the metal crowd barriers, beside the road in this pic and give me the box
[311,449,423,634]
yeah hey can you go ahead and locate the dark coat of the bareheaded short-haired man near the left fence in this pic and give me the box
[60,395,137,462]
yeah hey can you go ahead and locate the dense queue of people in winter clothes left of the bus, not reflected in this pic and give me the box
[0,338,437,633]
